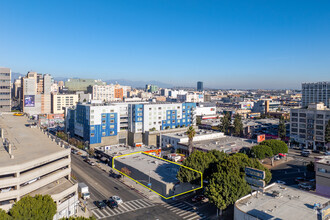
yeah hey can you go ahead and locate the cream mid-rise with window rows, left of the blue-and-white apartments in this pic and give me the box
[52,94,78,114]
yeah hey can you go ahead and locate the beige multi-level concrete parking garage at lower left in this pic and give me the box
[0,114,78,219]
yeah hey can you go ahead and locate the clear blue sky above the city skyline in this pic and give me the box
[0,0,330,88]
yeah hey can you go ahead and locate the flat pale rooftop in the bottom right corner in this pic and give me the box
[236,183,329,219]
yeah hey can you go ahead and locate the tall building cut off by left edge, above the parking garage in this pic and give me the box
[0,67,11,112]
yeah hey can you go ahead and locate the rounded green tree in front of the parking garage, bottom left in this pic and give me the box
[9,195,56,220]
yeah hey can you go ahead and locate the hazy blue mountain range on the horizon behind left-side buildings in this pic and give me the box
[11,72,173,88]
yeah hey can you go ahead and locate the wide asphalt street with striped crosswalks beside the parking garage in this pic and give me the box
[71,154,207,220]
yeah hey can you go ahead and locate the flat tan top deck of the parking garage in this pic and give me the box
[0,114,66,167]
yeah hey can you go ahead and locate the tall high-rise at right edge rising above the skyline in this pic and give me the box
[302,82,330,108]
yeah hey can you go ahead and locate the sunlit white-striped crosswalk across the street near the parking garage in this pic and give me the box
[92,199,155,219]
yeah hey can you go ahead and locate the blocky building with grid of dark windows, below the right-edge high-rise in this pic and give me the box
[290,103,330,150]
